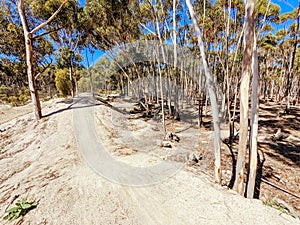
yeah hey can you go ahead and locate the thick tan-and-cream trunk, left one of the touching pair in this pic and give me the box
[235,0,255,195]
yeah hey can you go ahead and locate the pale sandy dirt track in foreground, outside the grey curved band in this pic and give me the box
[0,97,300,225]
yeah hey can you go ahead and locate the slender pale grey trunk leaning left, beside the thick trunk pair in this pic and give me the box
[186,0,221,183]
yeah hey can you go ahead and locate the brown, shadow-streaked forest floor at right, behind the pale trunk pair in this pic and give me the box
[210,102,300,215]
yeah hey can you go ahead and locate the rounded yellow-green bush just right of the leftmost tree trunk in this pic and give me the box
[55,69,70,97]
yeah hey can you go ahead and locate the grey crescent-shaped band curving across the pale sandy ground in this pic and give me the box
[72,95,183,186]
